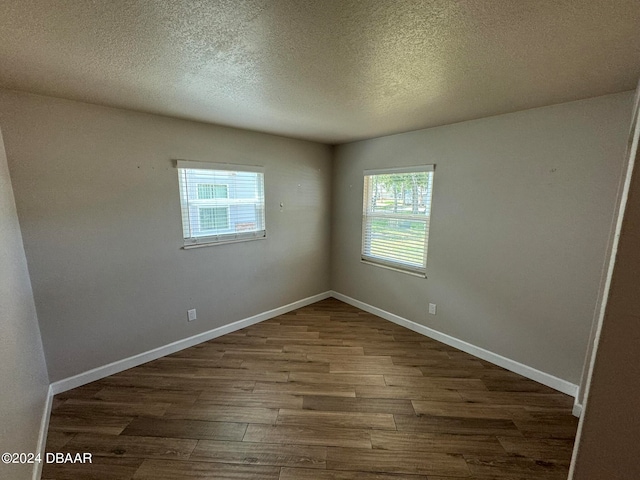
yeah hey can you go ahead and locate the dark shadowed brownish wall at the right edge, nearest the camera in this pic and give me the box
[571,91,640,480]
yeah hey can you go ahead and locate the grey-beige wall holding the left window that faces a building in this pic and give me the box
[0,91,331,381]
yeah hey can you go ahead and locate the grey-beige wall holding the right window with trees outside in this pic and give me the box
[331,93,632,384]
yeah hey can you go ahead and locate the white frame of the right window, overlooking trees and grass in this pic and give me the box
[360,164,435,278]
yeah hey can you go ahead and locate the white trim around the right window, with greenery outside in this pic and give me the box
[360,164,436,278]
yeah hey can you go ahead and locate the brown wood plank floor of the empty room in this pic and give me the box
[42,299,577,480]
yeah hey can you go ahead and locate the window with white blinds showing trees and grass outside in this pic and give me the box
[362,165,434,276]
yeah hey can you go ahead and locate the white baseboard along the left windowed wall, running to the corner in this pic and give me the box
[50,291,331,395]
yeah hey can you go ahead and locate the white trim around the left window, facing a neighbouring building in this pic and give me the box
[174,160,267,250]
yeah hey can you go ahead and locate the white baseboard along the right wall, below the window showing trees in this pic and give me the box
[331,292,578,398]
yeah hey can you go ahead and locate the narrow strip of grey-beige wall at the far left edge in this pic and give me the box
[0,125,49,480]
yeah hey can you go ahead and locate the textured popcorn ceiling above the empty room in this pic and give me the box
[0,0,640,143]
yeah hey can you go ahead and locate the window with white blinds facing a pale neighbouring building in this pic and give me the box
[176,160,266,248]
